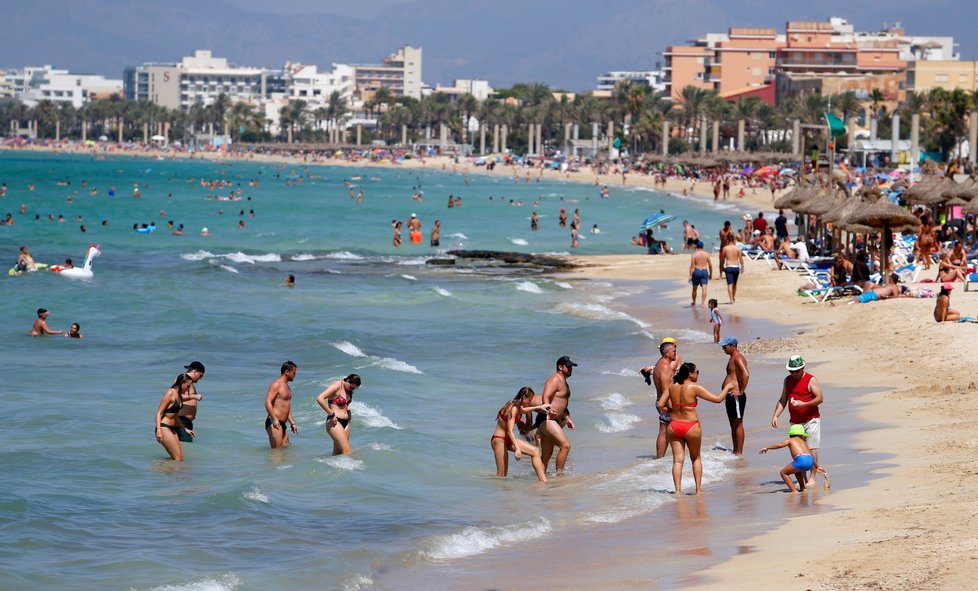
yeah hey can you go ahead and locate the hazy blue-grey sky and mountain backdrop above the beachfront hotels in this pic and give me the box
[0,0,978,91]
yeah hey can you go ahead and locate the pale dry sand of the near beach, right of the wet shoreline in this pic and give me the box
[560,256,978,589]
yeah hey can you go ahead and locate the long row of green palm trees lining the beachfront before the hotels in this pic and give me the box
[0,82,978,156]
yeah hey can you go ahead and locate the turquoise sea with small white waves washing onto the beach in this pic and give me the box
[0,152,878,591]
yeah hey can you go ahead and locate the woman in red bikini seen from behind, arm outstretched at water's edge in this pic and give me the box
[655,362,736,494]
